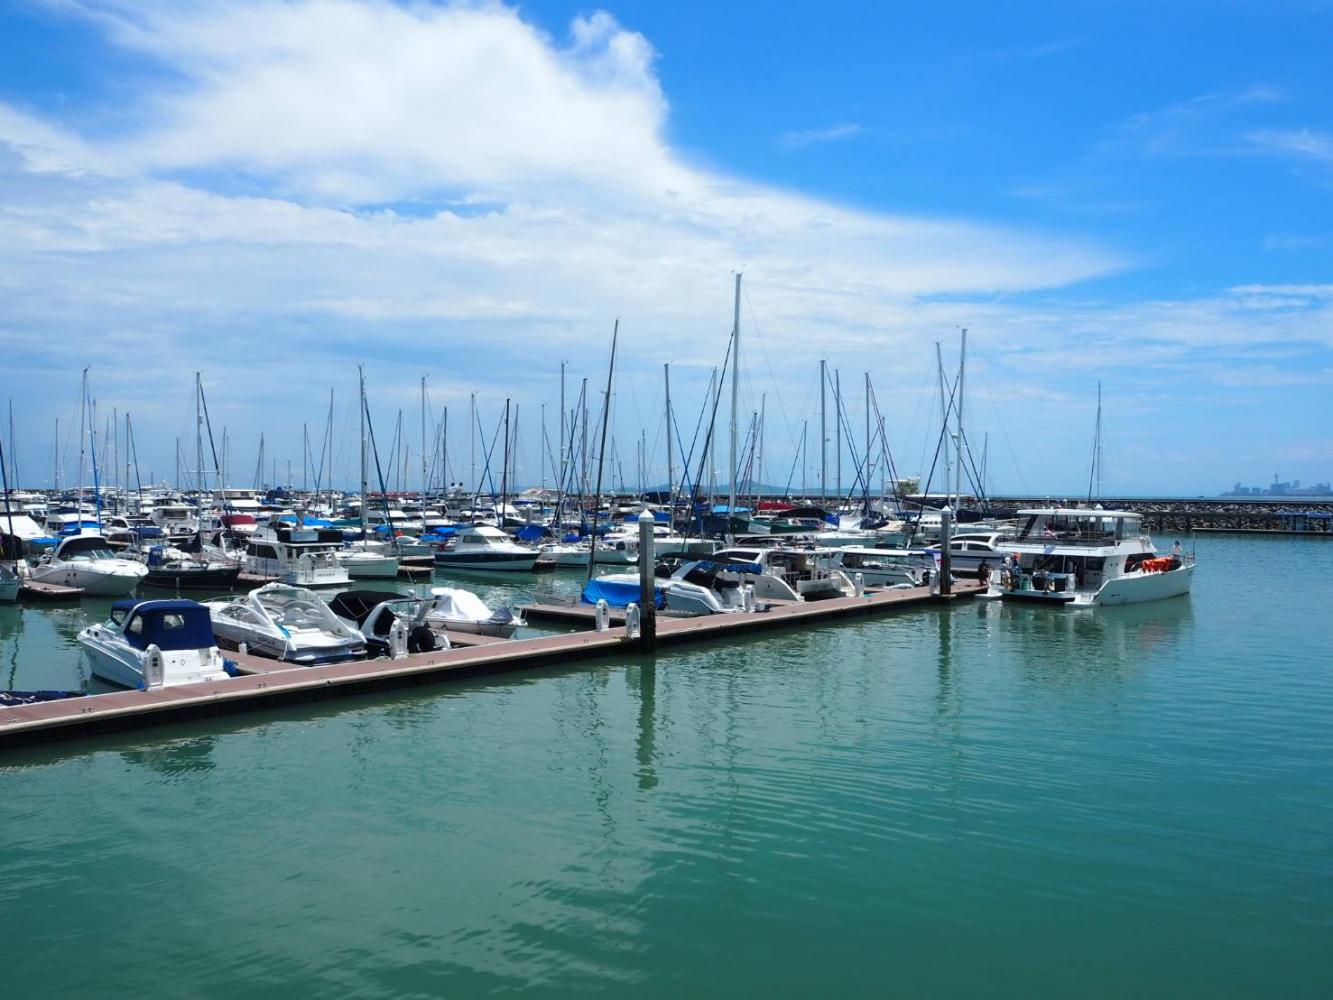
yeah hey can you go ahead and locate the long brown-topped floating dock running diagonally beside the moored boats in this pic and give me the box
[0,581,981,748]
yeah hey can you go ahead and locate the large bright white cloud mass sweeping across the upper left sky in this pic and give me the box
[0,0,1329,498]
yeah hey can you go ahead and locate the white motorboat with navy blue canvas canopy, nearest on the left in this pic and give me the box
[79,600,228,688]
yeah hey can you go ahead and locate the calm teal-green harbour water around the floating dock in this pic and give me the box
[0,539,1333,997]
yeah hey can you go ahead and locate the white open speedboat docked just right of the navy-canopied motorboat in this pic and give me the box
[204,584,365,667]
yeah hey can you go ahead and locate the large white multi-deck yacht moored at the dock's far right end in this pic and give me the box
[1000,507,1194,607]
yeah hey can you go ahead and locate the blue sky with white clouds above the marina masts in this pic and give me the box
[0,0,1333,496]
